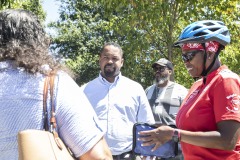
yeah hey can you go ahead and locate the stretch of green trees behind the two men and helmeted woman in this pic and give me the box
[49,0,240,88]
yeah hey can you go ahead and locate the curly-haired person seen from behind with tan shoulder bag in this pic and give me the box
[0,9,112,160]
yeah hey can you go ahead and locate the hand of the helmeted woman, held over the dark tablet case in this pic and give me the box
[138,125,174,152]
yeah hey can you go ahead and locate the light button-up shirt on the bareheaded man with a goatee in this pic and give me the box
[81,74,155,155]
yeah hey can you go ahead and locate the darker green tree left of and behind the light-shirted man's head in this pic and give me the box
[50,0,125,85]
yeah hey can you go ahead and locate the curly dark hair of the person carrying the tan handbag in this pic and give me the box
[0,9,67,74]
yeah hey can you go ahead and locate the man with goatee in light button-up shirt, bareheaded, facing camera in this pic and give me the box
[81,43,154,160]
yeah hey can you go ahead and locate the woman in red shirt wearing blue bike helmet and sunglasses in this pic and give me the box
[139,20,240,160]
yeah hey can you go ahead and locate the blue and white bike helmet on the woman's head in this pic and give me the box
[174,20,230,47]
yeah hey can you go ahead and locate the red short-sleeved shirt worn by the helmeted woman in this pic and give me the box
[176,66,240,160]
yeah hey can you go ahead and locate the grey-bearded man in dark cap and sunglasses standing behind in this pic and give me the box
[145,58,188,160]
